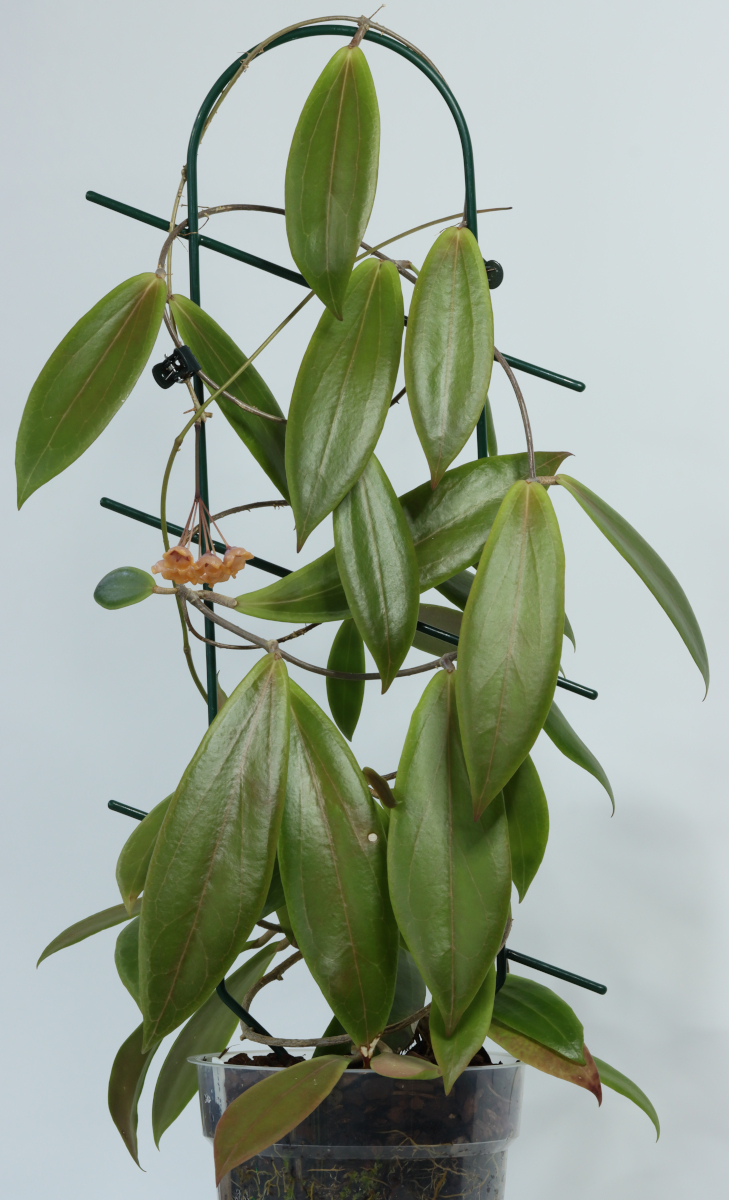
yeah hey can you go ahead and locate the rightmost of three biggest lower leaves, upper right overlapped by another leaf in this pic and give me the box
[387,671,511,1037]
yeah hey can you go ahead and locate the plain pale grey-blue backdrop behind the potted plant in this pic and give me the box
[0,0,728,1200]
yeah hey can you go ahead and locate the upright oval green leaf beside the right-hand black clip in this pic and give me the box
[404,228,494,487]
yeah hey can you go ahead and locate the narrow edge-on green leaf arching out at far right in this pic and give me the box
[558,475,709,691]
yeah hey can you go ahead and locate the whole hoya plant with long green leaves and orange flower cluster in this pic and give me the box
[24,11,709,1180]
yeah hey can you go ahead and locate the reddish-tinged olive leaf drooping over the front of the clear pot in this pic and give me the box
[215,1055,351,1184]
